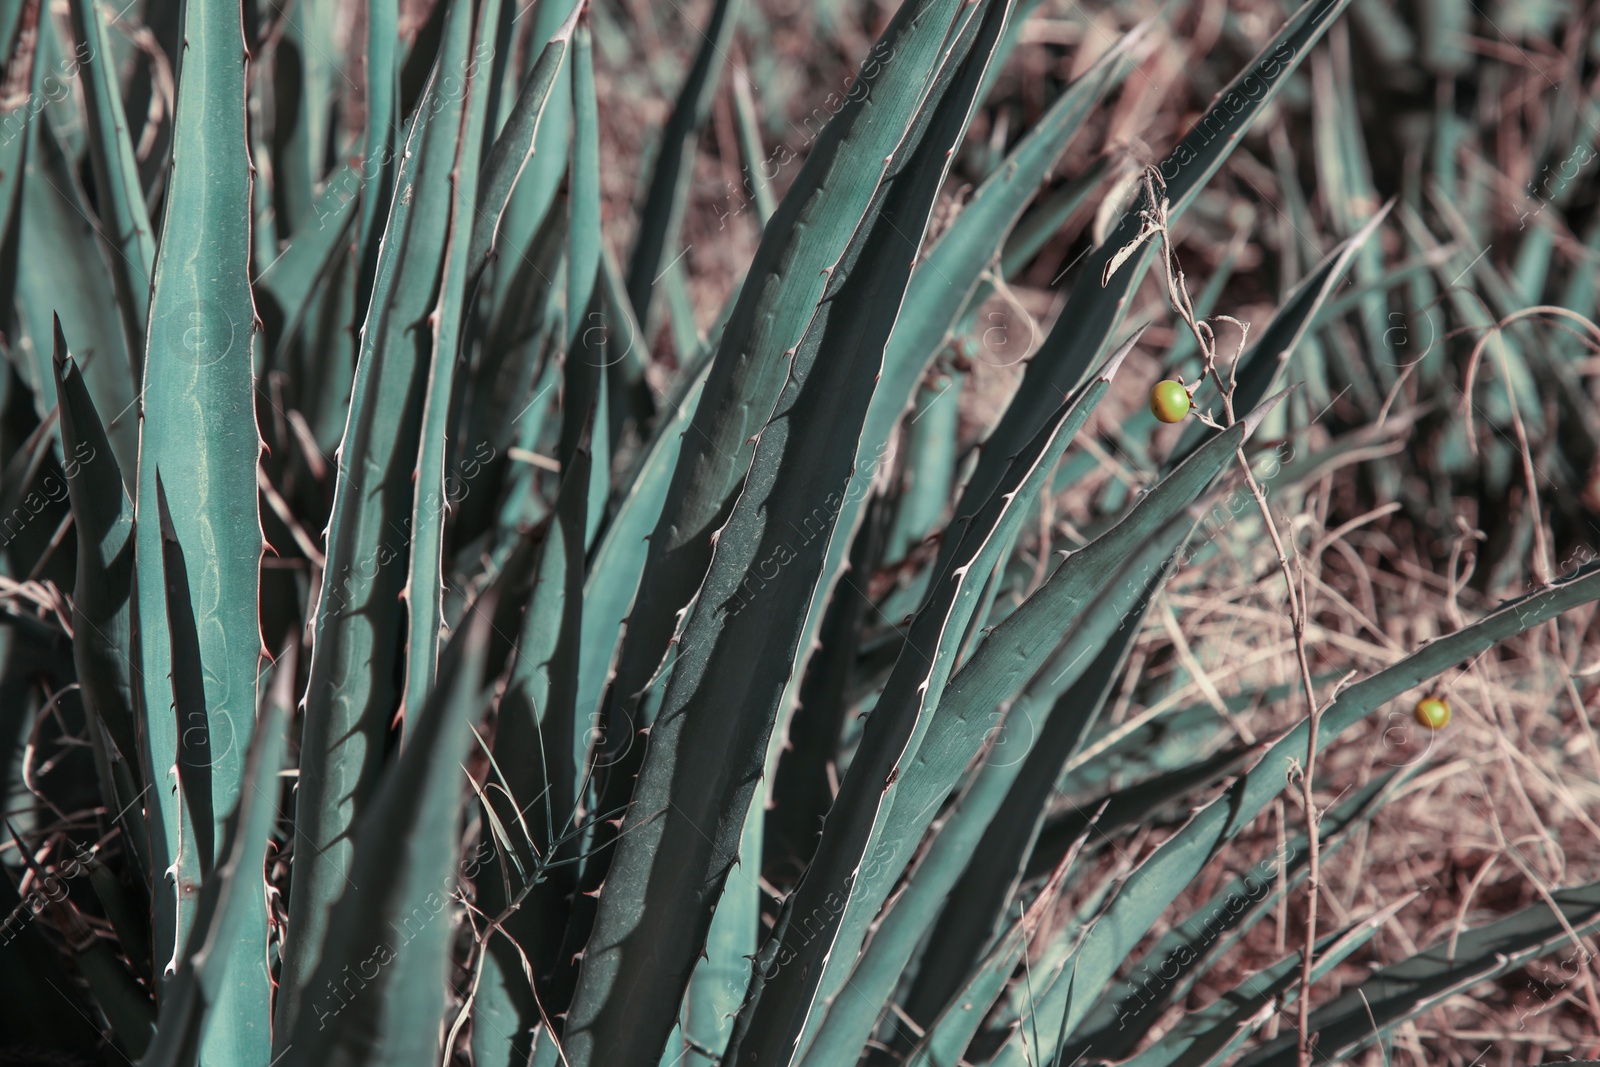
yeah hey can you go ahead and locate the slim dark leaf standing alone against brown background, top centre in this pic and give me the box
[627,0,741,330]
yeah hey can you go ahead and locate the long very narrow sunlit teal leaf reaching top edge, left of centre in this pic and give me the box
[402,0,501,715]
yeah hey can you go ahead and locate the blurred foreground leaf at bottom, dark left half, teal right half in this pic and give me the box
[283,598,499,1067]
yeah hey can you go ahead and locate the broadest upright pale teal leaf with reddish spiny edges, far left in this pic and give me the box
[134,2,272,1062]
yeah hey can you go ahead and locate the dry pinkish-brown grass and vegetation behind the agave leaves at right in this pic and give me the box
[600,0,1600,1067]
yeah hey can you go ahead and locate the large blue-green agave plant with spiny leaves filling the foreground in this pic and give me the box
[0,0,1600,1067]
